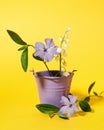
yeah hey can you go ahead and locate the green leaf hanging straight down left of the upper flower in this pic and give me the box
[21,48,28,72]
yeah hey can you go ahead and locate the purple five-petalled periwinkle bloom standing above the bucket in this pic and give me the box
[34,39,58,62]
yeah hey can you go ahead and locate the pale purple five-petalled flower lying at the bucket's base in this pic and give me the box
[60,95,79,118]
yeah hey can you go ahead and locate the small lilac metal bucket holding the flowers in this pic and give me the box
[34,71,73,107]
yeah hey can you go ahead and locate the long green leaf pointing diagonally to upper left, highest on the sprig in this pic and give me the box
[7,30,26,45]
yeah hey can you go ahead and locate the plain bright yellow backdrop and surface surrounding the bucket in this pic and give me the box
[0,0,104,130]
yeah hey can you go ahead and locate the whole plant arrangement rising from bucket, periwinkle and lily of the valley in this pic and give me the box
[7,28,70,76]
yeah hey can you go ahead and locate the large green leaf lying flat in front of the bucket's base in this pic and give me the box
[36,104,59,115]
